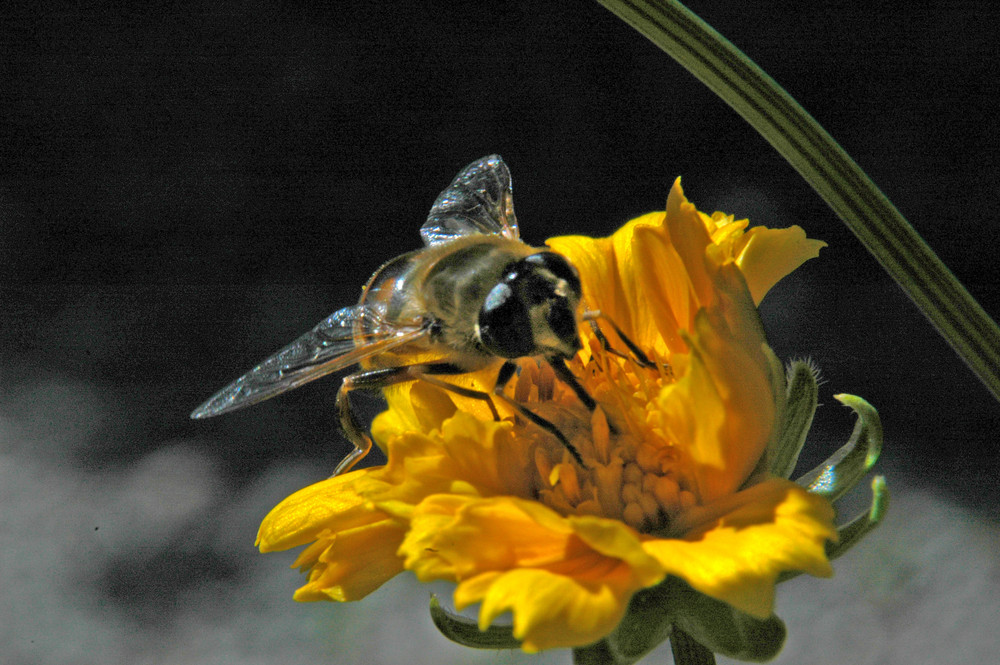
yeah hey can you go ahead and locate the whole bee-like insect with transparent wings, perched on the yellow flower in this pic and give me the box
[191,155,600,475]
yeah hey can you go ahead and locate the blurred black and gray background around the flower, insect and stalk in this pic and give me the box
[0,0,1000,665]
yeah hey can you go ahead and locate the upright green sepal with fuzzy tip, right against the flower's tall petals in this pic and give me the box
[768,360,819,478]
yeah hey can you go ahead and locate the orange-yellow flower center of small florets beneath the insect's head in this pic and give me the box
[514,341,696,533]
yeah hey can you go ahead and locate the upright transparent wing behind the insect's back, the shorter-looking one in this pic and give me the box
[420,155,518,246]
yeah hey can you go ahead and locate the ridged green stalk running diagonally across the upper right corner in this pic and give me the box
[598,0,1000,400]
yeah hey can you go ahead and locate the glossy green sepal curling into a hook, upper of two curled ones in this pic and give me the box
[795,395,882,501]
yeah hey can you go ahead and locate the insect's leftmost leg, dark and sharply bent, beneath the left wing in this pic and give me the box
[333,363,500,476]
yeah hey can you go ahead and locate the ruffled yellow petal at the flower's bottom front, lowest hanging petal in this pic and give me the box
[400,495,663,651]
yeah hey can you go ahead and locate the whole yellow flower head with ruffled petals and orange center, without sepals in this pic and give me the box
[258,181,837,651]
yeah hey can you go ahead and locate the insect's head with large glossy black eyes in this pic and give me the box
[476,252,580,358]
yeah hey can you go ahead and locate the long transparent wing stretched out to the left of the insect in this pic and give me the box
[191,304,426,419]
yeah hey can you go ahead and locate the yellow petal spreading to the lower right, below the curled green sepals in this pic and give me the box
[643,479,836,618]
